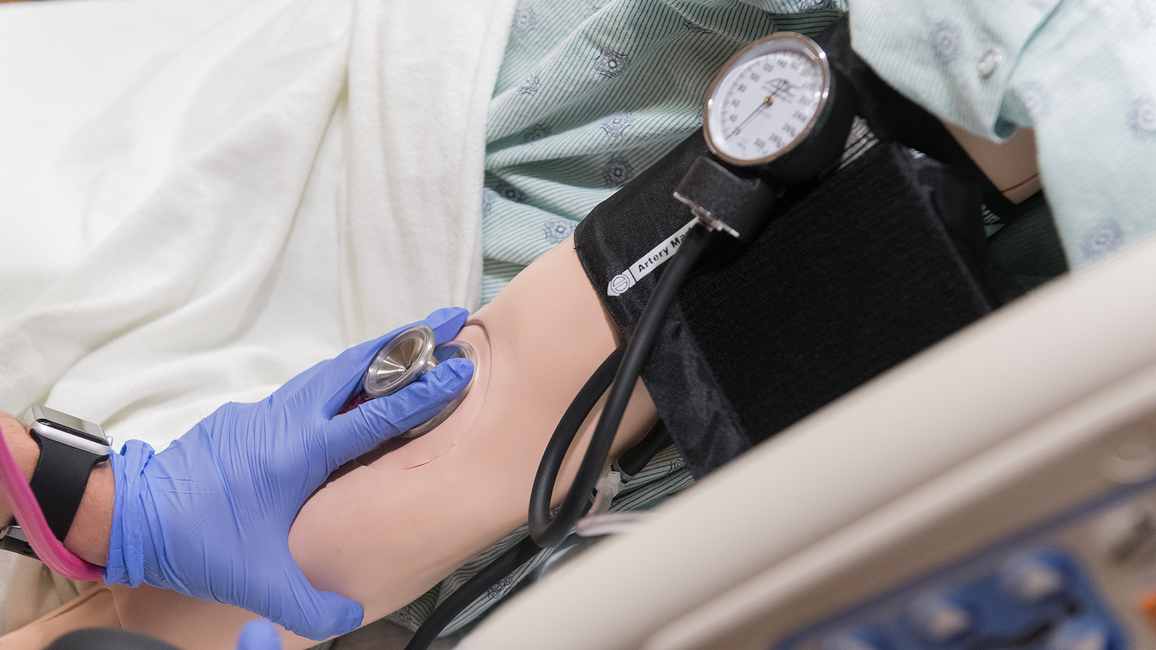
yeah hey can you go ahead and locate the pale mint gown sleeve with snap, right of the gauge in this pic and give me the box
[851,0,1156,271]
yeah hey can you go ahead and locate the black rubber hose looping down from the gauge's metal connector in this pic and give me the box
[529,224,711,548]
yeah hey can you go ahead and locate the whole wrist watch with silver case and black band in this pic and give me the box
[0,406,112,557]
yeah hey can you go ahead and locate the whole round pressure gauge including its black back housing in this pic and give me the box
[703,32,853,183]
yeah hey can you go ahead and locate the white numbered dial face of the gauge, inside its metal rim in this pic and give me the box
[711,51,823,160]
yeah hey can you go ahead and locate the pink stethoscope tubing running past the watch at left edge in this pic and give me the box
[0,416,103,581]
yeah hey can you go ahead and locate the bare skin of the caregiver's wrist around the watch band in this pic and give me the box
[0,414,114,566]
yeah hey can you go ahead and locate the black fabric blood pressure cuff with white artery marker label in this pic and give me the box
[575,134,1017,477]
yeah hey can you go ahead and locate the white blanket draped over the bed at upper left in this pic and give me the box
[0,0,513,629]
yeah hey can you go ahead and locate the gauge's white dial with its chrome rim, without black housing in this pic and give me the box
[705,35,830,164]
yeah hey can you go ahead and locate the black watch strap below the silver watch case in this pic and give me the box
[29,433,108,541]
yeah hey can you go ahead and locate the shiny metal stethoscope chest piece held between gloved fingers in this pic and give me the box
[341,325,477,440]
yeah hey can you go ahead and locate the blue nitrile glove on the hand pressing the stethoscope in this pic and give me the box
[104,309,473,640]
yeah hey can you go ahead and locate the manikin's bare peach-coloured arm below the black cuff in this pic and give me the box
[0,234,658,650]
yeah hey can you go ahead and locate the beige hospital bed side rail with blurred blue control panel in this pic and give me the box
[459,227,1156,650]
